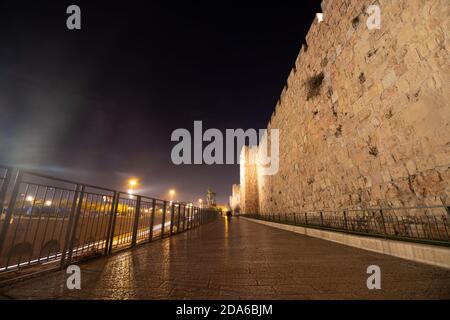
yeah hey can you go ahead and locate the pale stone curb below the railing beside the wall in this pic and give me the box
[239,217,450,269]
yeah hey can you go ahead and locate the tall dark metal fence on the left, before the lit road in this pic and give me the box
[0,167,217,275]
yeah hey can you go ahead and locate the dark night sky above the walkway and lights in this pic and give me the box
[0,0,321,203]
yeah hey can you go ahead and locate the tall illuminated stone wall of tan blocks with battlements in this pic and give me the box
[241,0,450,213]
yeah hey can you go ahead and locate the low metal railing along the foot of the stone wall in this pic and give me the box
[242,205,450,246]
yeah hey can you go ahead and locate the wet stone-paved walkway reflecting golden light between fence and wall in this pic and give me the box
[0,218,450,299]
